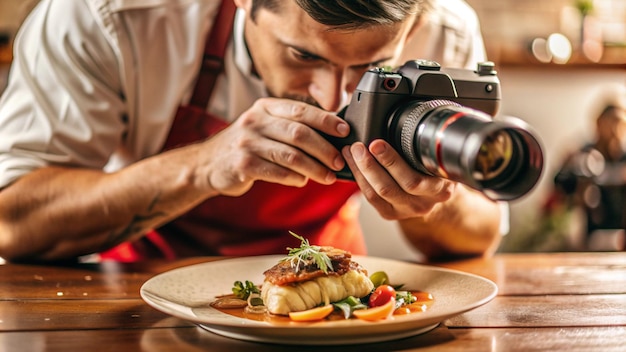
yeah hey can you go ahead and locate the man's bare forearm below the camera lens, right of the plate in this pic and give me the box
[399,184,501,259]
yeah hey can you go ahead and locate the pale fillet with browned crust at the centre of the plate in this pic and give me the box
[261,247,374,315]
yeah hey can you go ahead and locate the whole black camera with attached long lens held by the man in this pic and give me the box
[327,60,543,200]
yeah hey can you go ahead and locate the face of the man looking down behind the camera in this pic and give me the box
[241,1,414,111]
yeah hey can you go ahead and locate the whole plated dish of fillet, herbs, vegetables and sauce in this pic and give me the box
[211,233,433,322]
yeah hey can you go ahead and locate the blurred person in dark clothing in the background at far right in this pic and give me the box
[552,85,626,250]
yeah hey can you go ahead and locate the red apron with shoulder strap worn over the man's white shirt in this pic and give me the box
[101,1,366,261]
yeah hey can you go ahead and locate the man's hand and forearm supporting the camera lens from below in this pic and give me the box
[342,140,501,259]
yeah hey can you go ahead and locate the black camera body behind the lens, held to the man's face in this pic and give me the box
[339,60,501,148]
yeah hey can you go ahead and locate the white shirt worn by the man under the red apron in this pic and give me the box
[0,0,485,188]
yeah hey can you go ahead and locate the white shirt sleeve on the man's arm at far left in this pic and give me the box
[0,0,126,188]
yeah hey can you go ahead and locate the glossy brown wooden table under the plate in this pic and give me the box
[0,253,626,352]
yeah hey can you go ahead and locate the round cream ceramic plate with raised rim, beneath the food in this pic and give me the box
[141,255,498,345]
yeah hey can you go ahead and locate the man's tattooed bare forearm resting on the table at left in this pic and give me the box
[0,144,209,260]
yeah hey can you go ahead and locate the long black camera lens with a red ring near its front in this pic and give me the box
[387,100,543,200]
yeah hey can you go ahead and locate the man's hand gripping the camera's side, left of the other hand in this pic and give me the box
[197,98,349,195]
